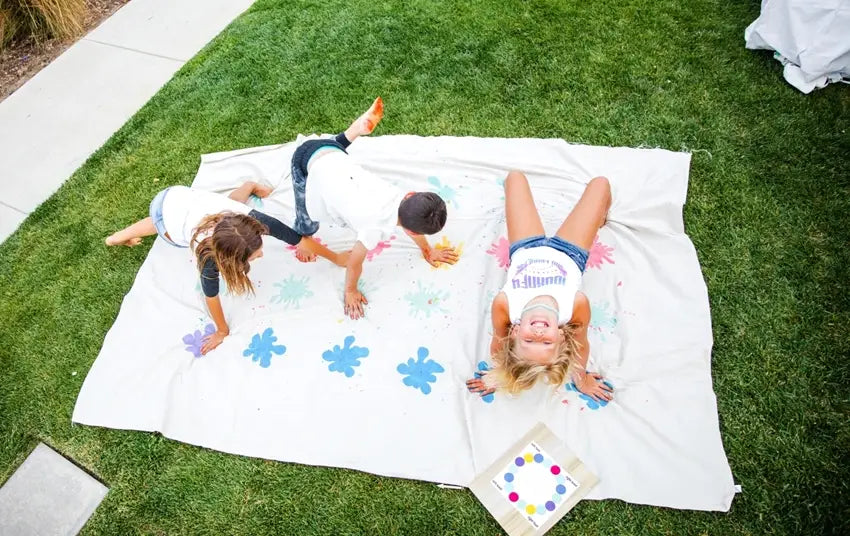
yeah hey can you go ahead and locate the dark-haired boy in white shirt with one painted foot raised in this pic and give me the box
[292,97,457,319]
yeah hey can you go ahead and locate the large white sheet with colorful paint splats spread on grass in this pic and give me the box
[73,136,734,511]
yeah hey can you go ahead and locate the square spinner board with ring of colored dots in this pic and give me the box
[470,424,598,536]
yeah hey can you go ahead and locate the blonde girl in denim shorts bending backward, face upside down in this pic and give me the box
[466,171,612,400]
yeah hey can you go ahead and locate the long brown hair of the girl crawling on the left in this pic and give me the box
[192,212,269,294]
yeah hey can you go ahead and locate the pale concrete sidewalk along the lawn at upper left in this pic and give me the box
[0,0,254,242]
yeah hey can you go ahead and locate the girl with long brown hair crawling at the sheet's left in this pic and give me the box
[106,182,348,354]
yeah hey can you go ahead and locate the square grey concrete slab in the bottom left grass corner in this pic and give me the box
[0,443,109,536]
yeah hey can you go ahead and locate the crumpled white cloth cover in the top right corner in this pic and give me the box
[744,0,850,93]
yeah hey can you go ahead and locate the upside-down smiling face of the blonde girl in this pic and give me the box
[511,296,563,365]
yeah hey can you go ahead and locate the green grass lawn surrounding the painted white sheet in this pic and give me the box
[0,0,850,535]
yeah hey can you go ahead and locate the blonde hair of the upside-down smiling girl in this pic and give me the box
[486,323,581,394]
